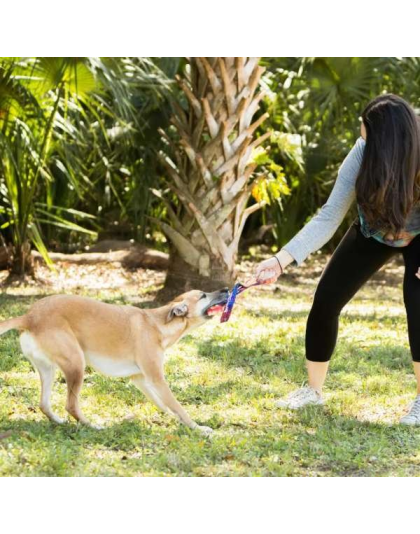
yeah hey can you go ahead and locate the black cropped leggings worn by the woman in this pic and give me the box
[306,221,420,362]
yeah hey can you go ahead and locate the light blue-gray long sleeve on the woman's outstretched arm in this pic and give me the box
[283,137,365,265]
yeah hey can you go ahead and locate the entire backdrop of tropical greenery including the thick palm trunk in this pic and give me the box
[0,57,420,278]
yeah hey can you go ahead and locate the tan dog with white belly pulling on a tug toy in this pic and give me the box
[0,289,228,434]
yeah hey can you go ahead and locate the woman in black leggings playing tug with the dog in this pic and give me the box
[256,94,420,425]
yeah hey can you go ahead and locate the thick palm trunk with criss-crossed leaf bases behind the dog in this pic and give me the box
[154,57,270,294]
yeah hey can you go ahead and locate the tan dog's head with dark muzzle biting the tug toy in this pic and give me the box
[167,288,229,330]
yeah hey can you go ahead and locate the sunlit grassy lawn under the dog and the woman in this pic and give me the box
[0,256,420,476]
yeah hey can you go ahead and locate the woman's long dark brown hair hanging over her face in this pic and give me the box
[356,94,420,236]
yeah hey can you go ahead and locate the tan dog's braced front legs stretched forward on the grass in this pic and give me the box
[131,375,213,435]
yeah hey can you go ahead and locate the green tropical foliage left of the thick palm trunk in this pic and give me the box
[0,58,175,274]
